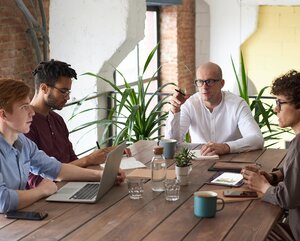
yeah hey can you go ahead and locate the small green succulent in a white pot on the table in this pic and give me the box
[174,147,195,185]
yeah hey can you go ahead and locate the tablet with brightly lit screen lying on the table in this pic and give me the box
[208,172,243,187]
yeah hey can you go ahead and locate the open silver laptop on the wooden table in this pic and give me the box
[46,142,126,203]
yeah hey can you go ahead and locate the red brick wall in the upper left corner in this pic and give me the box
[0,0,49,88]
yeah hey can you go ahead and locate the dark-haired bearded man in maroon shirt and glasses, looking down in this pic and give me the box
[26,59,130,188]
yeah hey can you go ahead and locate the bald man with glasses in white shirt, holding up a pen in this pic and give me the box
[165,62,264,155]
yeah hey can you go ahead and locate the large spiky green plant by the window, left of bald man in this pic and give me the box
[77,45,176,144]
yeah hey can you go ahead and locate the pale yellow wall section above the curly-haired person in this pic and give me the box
[241,6,300,94]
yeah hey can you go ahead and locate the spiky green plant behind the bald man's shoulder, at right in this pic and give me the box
[231,51,290,147]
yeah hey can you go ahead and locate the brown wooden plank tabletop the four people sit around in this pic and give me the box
[0,141,286,241]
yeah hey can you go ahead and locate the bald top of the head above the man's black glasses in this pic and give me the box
[196,62,223,80]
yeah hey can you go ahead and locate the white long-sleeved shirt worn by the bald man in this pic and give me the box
[165,91,264,153]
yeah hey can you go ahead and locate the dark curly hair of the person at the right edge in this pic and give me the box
[271,70,300,109]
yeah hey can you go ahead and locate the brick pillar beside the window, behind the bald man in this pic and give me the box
[160,0,195,96]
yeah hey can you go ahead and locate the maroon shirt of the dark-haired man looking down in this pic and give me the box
[26,111,78,188]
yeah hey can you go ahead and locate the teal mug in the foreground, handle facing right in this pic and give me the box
[194,191,225,218]
